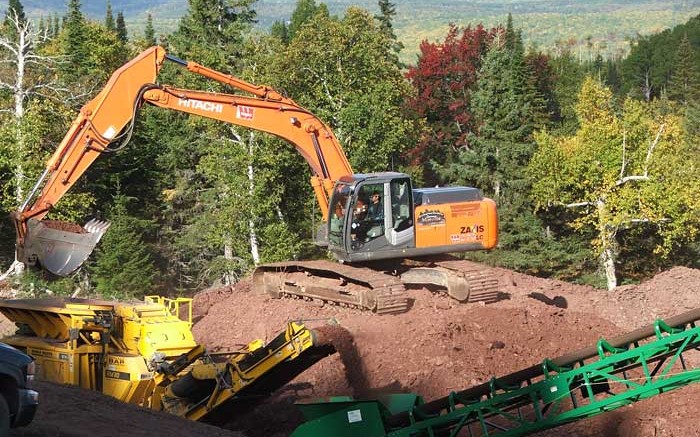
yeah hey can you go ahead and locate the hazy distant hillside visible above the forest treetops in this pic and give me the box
[3,0,700,62]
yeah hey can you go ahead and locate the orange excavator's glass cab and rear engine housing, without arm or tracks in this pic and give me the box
[328,172,498,263]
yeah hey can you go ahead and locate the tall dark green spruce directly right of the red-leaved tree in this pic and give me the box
[436,23,556,274]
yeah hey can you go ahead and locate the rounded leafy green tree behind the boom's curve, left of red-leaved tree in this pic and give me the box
[275,8,415,172]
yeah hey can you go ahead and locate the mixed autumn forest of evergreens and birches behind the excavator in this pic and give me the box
[0,0,700,297]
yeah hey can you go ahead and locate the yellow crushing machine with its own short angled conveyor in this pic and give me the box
[0,296,334,423]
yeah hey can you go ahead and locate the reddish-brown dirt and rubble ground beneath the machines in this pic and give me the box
[12,267,700,437]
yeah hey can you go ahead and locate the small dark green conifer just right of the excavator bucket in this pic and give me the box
[88,195,155,299]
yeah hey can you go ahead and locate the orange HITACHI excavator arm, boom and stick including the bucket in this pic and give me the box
[14,46,352,275]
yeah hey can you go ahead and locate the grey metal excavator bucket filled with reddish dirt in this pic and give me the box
[23,219,110,276]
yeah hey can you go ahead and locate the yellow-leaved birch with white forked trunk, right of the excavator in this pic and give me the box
[529,78,700,290]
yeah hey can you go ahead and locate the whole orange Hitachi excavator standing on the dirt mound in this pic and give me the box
[14,46,498,313]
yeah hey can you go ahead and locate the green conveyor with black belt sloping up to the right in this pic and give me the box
[292,310,700,437]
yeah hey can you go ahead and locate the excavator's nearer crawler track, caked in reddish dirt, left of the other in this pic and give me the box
[253,261,409,314]
